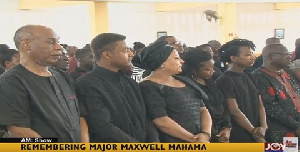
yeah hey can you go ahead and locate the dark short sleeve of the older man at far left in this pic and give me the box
[0,76,30,129]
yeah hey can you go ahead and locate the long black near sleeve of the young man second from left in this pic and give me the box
[76,83,139,143]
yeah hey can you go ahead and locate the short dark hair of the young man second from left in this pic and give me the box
[91,33,126,61]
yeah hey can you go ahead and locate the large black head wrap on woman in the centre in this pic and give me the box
[132,41,174,71]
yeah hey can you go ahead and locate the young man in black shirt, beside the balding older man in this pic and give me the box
[76,33,158,142]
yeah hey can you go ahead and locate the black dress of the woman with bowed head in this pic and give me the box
[197,79,232,142]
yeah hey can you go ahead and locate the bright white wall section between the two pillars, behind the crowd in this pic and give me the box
[109,3,219,46]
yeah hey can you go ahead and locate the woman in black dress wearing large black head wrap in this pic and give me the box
[132,41,212,143]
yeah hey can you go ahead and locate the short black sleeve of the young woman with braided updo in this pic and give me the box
[217,77,236,99]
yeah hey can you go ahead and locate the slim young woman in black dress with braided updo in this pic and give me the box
[217,39,267,142]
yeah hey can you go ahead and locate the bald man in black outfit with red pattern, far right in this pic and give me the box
[253,44,300,142]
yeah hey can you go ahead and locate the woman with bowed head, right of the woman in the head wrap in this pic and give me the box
[183,49,231,142]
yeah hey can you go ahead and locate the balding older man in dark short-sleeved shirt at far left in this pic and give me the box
[0,25,80,142]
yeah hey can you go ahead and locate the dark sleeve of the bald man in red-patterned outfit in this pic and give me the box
[256,75,300,129]
